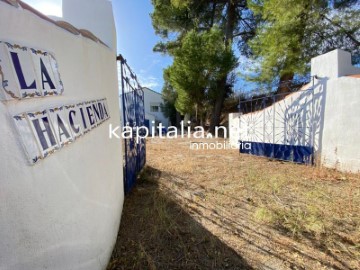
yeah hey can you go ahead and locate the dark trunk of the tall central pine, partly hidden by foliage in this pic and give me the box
[209,0,236,134]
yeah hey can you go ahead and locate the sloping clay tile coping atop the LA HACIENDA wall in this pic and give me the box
[0,0,108,47]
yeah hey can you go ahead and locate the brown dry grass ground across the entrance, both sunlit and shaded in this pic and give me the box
[108,138,360,270]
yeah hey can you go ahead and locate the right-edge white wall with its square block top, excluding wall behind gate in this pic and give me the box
[318,50,360,172]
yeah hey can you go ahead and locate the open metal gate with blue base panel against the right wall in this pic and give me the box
[239,78,328,164]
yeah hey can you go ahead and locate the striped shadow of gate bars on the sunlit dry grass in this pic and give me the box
[138,167,352,270]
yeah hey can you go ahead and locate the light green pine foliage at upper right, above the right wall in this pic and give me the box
[249,0,360,92]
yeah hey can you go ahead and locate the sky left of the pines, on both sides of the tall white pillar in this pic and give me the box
[23,0,172,92]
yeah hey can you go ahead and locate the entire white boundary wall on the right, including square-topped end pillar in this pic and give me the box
[229,50,360,172]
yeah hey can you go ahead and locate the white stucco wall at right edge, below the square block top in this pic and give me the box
[321,77,360,172]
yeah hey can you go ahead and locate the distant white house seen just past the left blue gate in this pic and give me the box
[143,87,169,132]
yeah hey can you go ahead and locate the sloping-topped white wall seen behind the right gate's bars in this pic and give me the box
[229,85,320,146]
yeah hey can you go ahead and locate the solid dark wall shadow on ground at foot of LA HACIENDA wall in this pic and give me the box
[107,166,253,270]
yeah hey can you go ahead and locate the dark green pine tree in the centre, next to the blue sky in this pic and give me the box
[151,0,254,132]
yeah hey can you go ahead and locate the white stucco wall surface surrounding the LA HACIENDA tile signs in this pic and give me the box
[0,1,123,270]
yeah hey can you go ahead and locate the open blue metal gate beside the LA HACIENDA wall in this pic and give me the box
[117,55,146,194]
